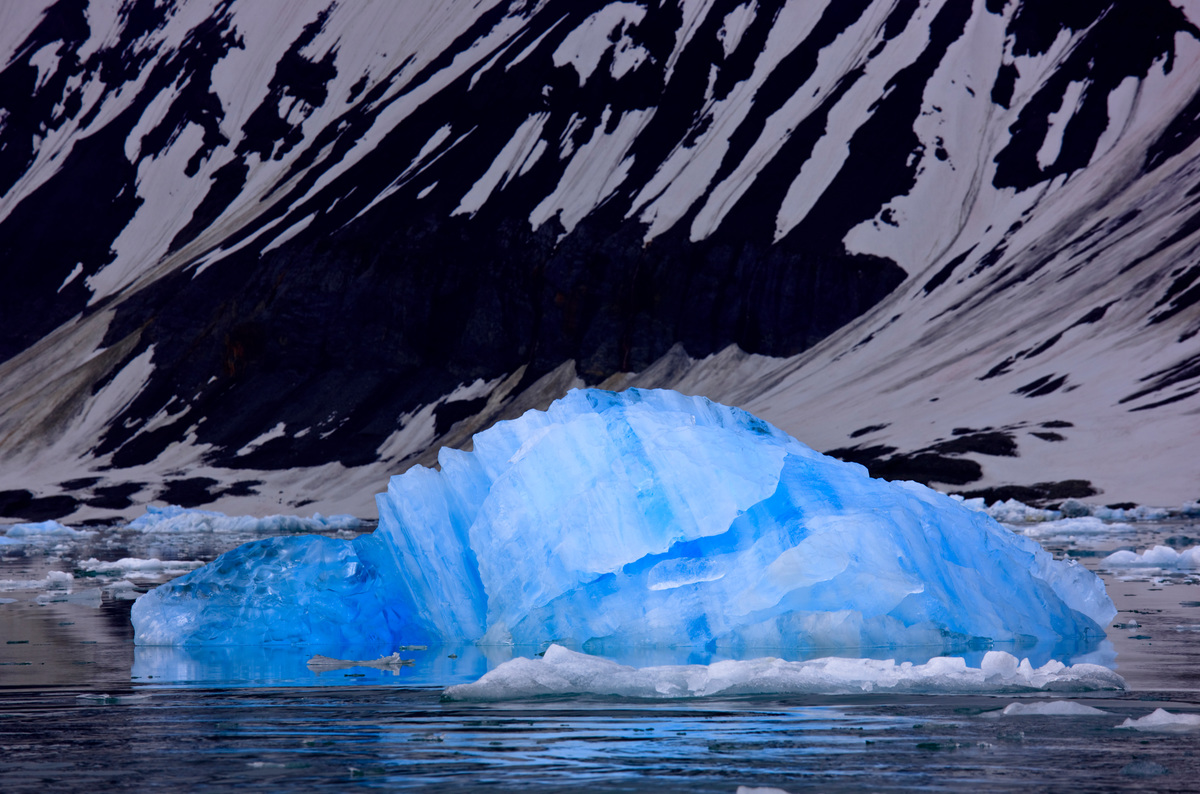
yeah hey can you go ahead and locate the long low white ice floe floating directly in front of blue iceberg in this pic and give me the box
[443,645,1126,700]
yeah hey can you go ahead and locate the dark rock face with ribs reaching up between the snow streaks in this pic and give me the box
[0,0,916,479]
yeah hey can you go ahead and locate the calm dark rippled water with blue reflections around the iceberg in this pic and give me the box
[0,522,1200,794]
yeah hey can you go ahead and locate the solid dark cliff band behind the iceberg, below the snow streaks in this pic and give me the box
[91,211,902,468]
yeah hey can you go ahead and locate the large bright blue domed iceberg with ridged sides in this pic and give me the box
[132,390,1116,654]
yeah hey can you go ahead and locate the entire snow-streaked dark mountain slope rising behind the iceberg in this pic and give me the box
[0,0,1200,519]
